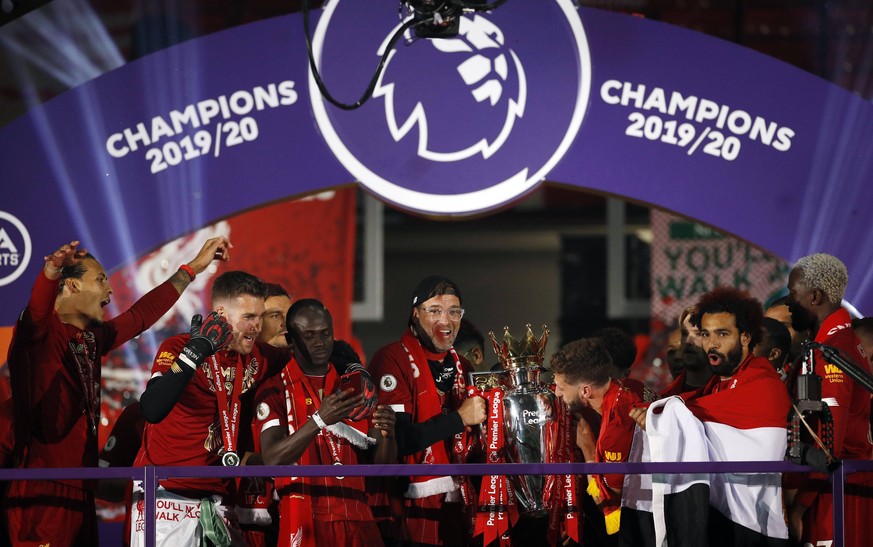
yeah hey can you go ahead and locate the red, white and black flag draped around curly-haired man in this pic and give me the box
[619,358,790,547]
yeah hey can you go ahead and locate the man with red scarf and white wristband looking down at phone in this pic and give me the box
[252,299,397,547]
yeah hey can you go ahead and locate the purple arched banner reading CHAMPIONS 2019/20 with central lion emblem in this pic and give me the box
[0,0,873,316]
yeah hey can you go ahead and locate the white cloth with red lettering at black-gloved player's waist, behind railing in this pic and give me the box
[130,488,245,547]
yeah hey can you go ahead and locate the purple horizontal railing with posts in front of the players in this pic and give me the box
[0,460,873,547]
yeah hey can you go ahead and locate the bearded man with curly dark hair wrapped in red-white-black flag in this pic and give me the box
[621,287,791,546]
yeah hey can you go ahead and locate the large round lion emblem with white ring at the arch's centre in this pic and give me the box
[309,0,591,214]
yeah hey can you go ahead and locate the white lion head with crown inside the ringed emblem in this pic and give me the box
[373,14,527,162]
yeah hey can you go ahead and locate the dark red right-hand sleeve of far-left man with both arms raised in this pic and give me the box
[98,281,179,355]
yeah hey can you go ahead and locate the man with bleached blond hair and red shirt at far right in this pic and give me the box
[788,253,873,546]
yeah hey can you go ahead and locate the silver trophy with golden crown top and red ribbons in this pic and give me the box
[471,325,556,516]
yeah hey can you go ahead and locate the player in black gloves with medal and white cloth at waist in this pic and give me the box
[131,271,291,547]
